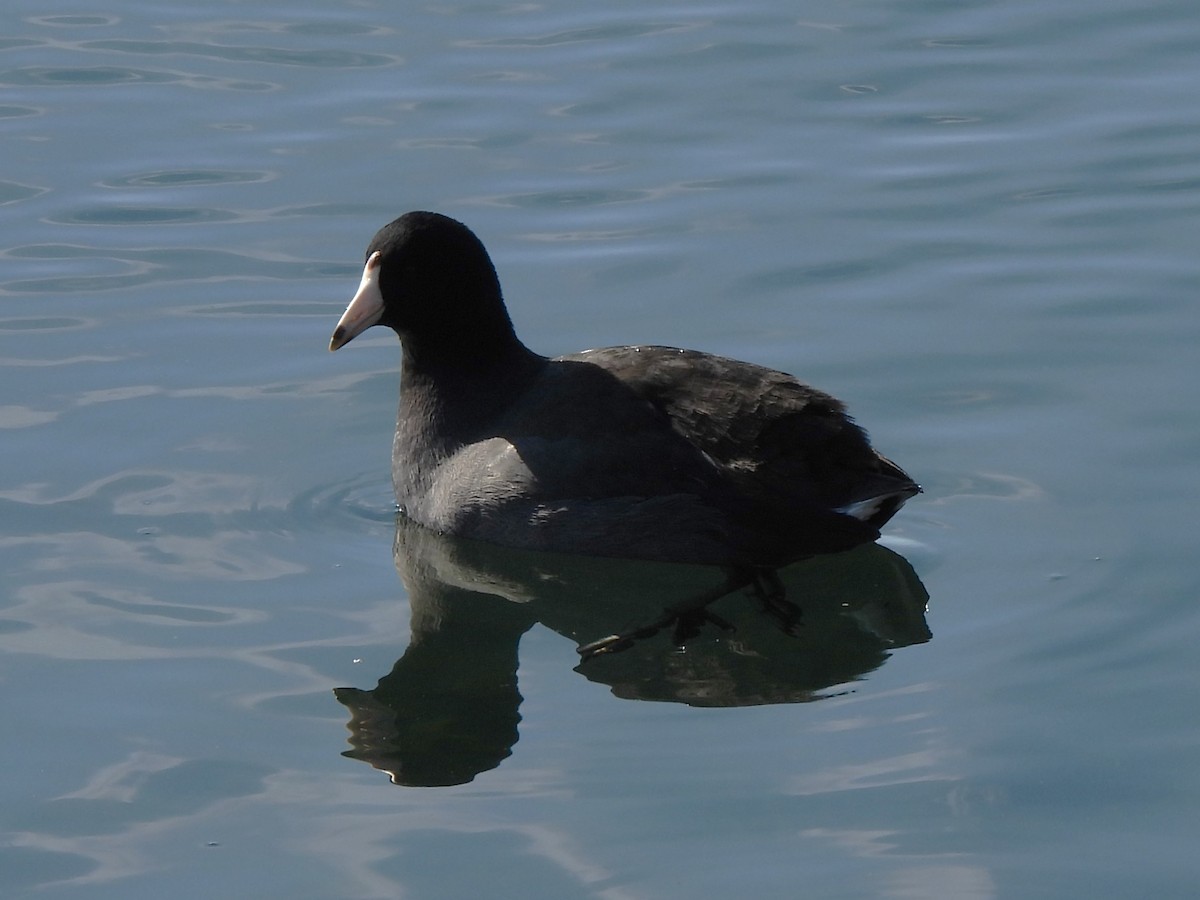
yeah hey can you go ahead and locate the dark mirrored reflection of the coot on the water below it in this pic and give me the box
[335,516,930,786]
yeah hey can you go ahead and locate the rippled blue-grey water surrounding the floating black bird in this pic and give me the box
[0,0,1200,899]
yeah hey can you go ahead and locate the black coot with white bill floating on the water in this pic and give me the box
[329,212,920,568]
